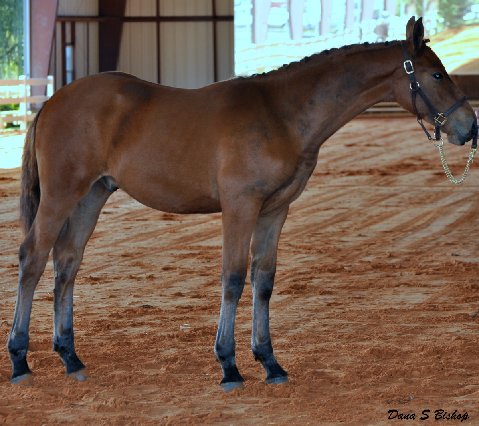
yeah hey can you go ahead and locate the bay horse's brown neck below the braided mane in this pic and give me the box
[270,45,402,153]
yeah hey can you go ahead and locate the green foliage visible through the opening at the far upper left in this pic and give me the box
[0,0,24,79]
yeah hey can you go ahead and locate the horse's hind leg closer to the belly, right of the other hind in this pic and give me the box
[53,180,114,381]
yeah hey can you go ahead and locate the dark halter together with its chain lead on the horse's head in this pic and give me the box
[401,42,479,185]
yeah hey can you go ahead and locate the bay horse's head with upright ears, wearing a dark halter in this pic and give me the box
[393,17,477,145]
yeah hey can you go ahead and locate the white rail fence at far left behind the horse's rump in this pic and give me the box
[0,75,54,133]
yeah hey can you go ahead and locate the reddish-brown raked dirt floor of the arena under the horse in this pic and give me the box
[0,116,479,425]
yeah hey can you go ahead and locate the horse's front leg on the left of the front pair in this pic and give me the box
[215,200,260,391]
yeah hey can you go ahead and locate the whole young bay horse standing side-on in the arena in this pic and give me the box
[8,17,477,390]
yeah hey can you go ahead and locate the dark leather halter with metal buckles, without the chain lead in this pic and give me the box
[401,42,478,148]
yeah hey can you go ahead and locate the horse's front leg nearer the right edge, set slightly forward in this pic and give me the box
[251,208,288,383]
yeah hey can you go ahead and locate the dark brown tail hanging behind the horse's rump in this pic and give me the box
[20,107,43,235]
